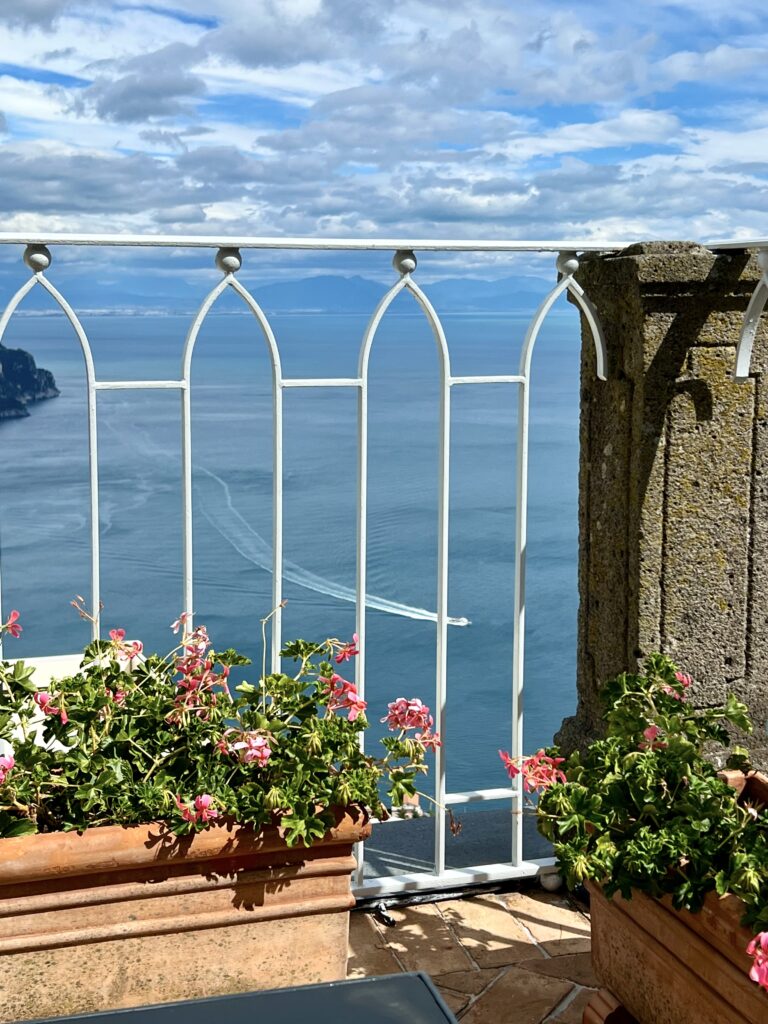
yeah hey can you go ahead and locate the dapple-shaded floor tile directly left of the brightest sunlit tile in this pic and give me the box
[386,903,473,978]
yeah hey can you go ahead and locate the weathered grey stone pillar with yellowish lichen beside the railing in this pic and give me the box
[557,243,768,768]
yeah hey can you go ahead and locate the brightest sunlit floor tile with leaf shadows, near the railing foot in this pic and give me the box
[437,896,543,968]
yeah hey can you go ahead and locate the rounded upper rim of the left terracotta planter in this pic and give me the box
[0,807,371,886]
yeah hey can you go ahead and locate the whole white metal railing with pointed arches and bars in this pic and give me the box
[0,233,768,895]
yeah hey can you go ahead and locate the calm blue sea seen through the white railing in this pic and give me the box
[0,300,579,806]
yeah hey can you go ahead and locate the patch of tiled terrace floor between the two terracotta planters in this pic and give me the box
[347,889,597,1024]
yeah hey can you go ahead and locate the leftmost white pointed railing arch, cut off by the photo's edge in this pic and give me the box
[0,245,101,655]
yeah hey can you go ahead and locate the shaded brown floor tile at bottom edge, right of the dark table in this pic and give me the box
[462,967,573,1024]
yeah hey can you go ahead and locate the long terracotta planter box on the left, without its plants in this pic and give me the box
[0,814,371,1021]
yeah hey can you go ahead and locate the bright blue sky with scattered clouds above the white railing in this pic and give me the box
[0,0,768,288]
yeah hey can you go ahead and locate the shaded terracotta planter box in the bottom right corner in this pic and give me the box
[584,772,768,1024]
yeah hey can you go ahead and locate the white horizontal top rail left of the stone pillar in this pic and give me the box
[0,231,630,253]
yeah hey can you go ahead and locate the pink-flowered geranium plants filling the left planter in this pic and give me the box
[0,608,439,845]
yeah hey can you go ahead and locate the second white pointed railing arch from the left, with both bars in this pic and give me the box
[181,248,283,672]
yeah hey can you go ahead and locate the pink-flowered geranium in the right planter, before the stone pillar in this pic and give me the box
[500,654,768,990]
